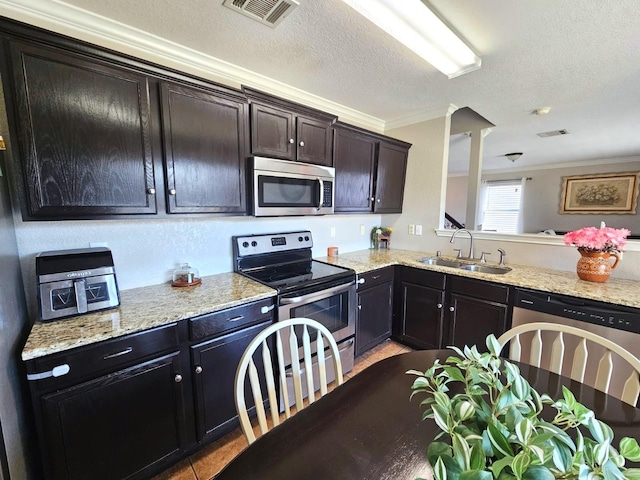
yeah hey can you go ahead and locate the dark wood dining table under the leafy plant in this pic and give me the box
[215,350,640,480]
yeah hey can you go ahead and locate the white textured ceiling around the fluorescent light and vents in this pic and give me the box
[0,0,640,171]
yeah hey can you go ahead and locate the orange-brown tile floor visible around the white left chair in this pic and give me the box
[153,340,411,480]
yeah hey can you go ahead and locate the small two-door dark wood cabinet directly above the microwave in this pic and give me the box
[243,87,336,166]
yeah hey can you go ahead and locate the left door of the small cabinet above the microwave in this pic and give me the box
[251,103,296,160]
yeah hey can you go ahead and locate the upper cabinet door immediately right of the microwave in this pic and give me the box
[333,128,376,212]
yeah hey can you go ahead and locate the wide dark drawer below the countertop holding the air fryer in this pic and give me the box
[27,323,179,390]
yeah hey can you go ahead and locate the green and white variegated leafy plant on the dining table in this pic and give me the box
[407,335,640,480]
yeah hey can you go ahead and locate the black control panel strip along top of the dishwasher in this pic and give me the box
[514,288,640,333]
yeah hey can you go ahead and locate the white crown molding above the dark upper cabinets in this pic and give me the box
[0,0,385,133]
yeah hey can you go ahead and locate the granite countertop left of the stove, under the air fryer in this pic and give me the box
[22,273,277,360]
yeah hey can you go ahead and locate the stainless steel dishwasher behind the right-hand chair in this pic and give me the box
[512,288,640,397]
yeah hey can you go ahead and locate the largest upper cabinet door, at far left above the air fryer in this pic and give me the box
[11,43,156,218]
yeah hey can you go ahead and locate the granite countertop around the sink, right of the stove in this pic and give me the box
[318,249,640,308]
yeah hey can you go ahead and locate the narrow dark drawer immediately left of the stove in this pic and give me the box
[189,298,274,340]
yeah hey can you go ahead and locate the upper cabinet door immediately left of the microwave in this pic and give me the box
[162,83,247,213]
